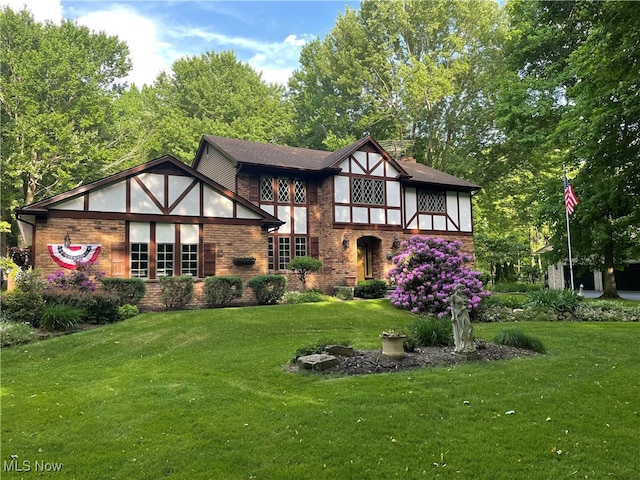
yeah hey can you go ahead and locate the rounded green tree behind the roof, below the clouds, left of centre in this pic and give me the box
[145,52,291,161]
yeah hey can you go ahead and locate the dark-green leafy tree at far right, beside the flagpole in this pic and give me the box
[508,1,640,297]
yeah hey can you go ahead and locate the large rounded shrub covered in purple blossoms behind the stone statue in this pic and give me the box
[387,236,489,317]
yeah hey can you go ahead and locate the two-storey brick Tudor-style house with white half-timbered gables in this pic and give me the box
[17,135,480,307]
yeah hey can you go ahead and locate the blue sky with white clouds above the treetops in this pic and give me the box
[0,0,359,86]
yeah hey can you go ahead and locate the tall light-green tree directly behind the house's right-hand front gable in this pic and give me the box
[289,0,504,173]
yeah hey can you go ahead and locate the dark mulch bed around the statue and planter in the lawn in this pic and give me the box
[286,342,540,375]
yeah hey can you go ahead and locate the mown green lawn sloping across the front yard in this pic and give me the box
[1,300,640,480]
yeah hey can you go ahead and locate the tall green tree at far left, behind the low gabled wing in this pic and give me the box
[0,8,131,216]
